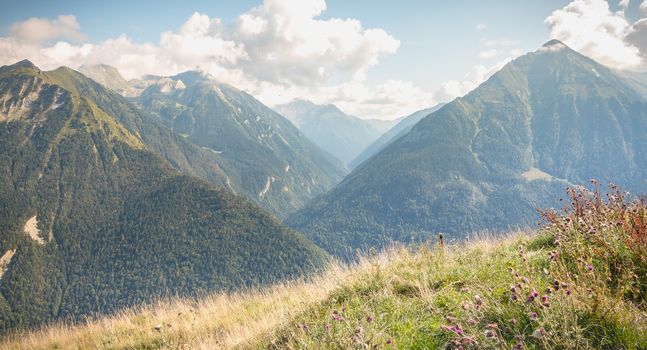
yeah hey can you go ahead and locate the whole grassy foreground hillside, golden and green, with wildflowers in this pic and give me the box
[0,182,647,349]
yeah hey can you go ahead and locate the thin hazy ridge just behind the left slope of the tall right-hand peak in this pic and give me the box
[348,104,444,170]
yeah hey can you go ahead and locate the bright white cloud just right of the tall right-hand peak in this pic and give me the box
[546,0,645,69]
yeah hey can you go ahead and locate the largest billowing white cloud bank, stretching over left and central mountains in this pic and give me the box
[0,0,528,119]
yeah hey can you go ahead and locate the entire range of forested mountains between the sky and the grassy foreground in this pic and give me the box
[0,40,647,333]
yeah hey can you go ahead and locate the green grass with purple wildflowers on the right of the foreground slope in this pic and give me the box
[258,187,647,349]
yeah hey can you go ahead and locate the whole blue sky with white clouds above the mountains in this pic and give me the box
[0,0,647,119]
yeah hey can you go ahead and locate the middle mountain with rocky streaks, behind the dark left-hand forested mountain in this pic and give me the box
[133,72,346,217]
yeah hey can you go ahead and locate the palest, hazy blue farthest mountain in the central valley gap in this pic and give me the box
[274,100,397,164]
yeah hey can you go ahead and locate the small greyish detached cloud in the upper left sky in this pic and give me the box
[9,15,85,44]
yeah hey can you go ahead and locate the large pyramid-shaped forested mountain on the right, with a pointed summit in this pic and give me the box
[287,40,647,258]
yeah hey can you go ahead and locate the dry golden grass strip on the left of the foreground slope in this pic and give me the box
[0,255,404,349]
